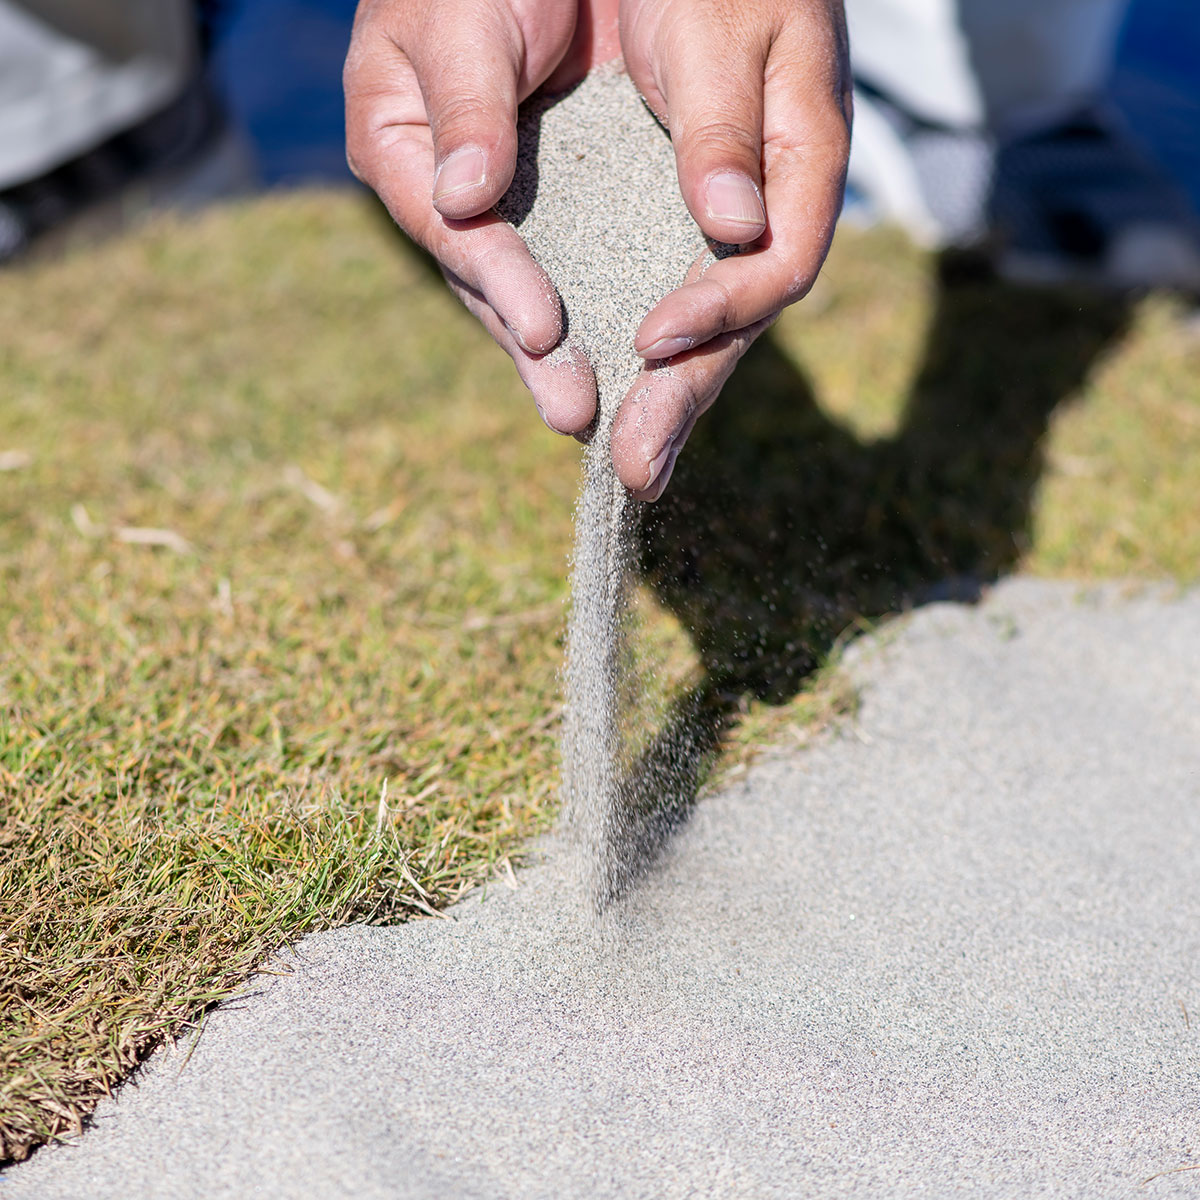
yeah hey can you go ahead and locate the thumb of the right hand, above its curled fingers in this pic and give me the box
[660,29,767,245]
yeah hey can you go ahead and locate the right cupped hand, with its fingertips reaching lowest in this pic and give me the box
[612,0,851,500]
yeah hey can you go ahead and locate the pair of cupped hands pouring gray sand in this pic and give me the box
[346,0,850,499]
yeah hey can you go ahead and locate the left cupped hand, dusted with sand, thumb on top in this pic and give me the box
[344,0,619,433]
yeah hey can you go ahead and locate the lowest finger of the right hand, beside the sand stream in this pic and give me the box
[612,318,773,500]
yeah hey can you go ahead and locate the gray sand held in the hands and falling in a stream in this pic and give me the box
[499,68,706,907]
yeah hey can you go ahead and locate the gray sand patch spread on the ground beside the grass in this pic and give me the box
[9,582,1200,1200]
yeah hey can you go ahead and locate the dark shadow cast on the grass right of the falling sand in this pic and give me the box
[611,257,1129,899]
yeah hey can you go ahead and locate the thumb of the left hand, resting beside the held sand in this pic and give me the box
[409,18,521,220]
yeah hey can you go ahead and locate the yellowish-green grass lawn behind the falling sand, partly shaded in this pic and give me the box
[0,193,1200,1158]
